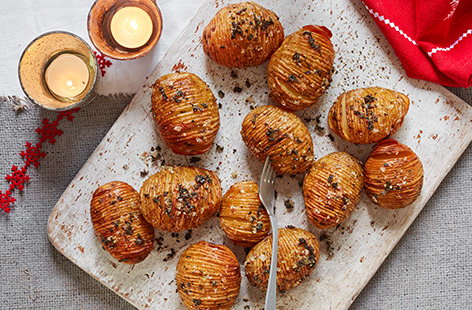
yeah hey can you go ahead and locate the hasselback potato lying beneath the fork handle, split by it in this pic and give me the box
[244,227,320,292]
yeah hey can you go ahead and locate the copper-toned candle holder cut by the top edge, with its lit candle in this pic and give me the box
[87,0,162,60]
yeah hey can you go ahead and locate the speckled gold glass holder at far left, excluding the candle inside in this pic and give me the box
[18,31,98,111]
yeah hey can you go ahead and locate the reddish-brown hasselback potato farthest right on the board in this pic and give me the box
[365,139,423,209]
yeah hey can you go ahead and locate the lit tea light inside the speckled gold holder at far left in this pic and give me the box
[44,53,90,98]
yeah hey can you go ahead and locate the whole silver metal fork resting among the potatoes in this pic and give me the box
[259,156,279,310]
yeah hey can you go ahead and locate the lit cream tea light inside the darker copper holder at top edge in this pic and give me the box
[110,6,153,49]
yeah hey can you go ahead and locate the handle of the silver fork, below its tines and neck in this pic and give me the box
[264,214,279,310]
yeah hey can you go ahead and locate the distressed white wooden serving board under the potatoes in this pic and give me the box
[48,0,472,310]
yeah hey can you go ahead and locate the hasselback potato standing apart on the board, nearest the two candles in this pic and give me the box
[152,72,220,155]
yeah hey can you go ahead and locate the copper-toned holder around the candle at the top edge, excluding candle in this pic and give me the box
[87,0,162,60]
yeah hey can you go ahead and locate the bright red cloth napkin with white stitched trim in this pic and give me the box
[363,0,472,87]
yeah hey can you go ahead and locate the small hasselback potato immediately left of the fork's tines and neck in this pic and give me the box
[220,182,270,248]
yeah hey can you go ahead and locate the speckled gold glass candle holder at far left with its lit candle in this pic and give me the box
[18,31,98,111]
